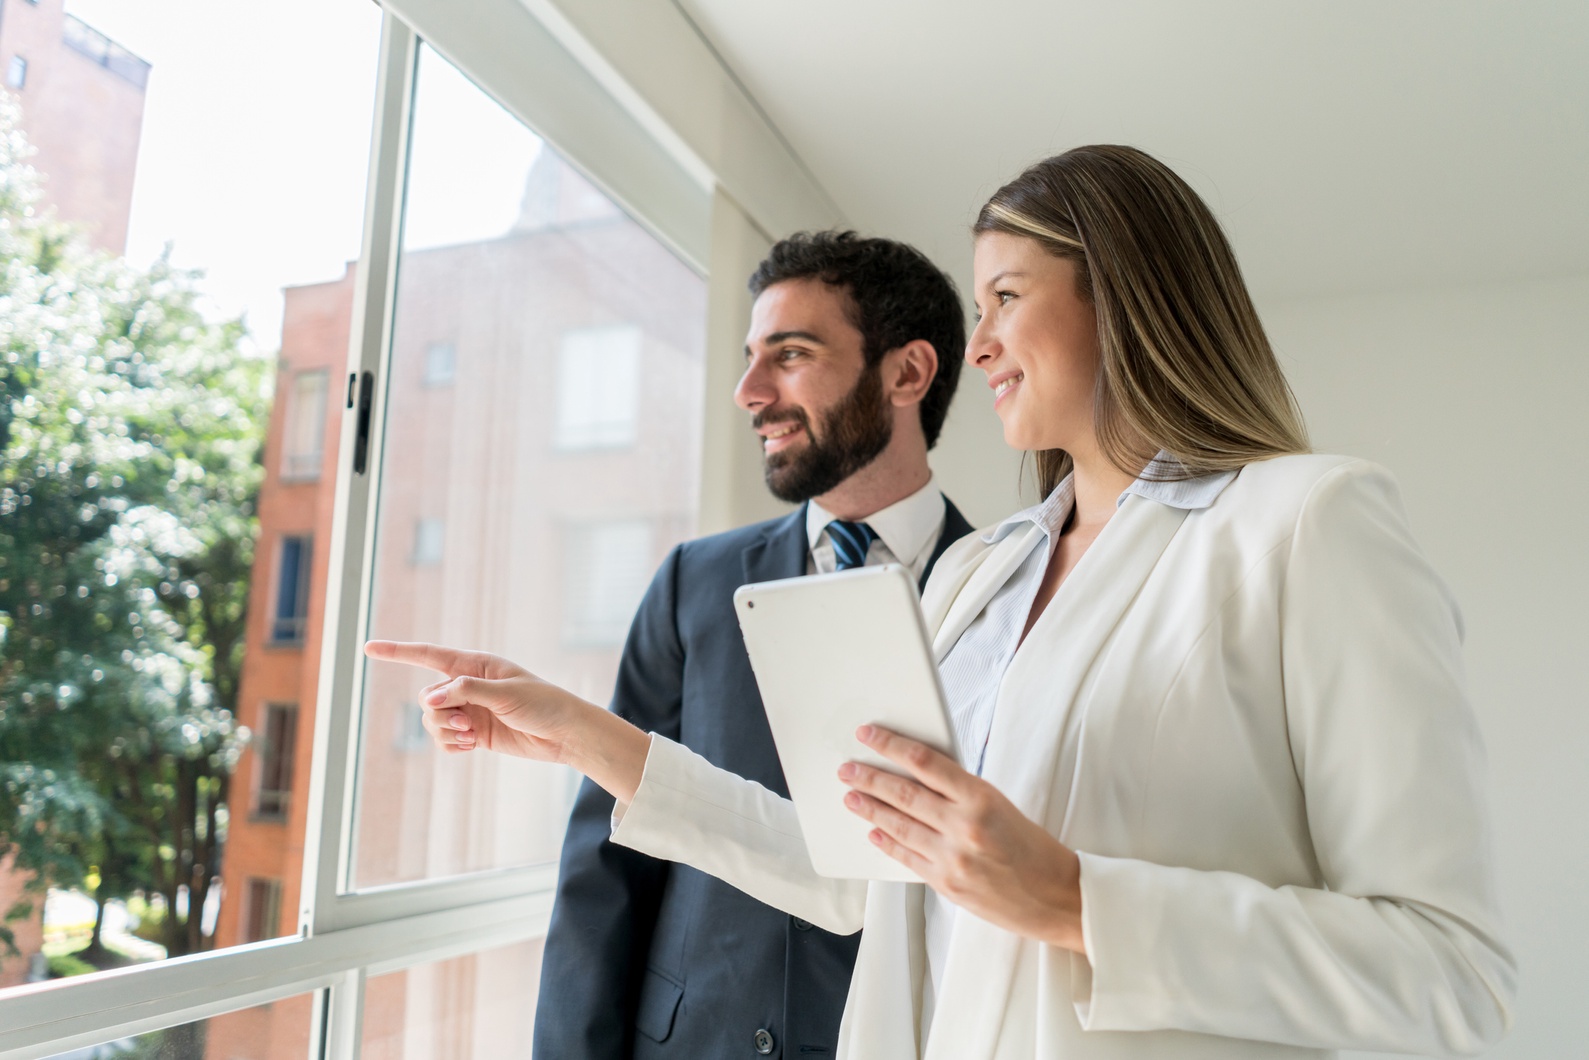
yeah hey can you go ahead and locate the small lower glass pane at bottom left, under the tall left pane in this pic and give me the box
[49,993,316,1060]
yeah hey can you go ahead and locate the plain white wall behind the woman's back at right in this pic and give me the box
[1262,277,1589,1060]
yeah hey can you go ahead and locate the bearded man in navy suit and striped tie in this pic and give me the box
[534,232,971,1060]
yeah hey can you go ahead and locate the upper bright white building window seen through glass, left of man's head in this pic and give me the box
[556,324,640,450]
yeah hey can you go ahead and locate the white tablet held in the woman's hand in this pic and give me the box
[734,564,955,884]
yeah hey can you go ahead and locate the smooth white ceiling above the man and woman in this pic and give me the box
[677,0,1589,297]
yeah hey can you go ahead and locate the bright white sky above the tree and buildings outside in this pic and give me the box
[67,0,540,350]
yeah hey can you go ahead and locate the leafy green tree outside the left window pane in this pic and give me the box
[0,103,272,972]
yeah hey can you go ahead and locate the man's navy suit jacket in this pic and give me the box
[534,501,971,1060]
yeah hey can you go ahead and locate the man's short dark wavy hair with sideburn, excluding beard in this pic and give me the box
[750,232,966,448]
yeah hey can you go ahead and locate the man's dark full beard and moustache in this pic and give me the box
[752,364,893,504]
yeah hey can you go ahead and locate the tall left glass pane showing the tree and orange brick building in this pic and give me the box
[0,0,380,988]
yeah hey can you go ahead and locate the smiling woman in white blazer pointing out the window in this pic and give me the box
[369,146,1514,1060]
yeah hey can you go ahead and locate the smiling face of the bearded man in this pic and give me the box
[734,280,893,504]
